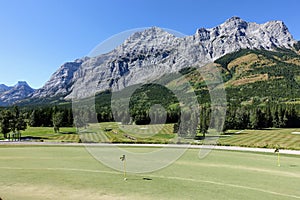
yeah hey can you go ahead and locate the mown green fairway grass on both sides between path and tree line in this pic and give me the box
[0,122,300,150]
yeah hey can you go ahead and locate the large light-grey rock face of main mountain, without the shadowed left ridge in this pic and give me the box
[67,17,296,98]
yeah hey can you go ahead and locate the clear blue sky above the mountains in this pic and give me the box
[0,0,300,88]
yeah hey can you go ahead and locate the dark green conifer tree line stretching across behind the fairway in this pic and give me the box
[0,102,300,138]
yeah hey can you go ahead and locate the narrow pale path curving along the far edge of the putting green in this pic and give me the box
[0,141,300,155]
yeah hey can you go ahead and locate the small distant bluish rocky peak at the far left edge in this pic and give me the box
[0,81,35,106]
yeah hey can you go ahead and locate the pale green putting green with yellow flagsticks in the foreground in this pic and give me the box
[0,146,300,200]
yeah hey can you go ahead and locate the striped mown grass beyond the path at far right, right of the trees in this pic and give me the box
[218,128,300,150]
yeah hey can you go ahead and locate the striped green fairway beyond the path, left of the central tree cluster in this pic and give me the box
[8,122,176,143]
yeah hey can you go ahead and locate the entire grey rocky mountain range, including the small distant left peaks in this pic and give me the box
[0,17,299,105]
